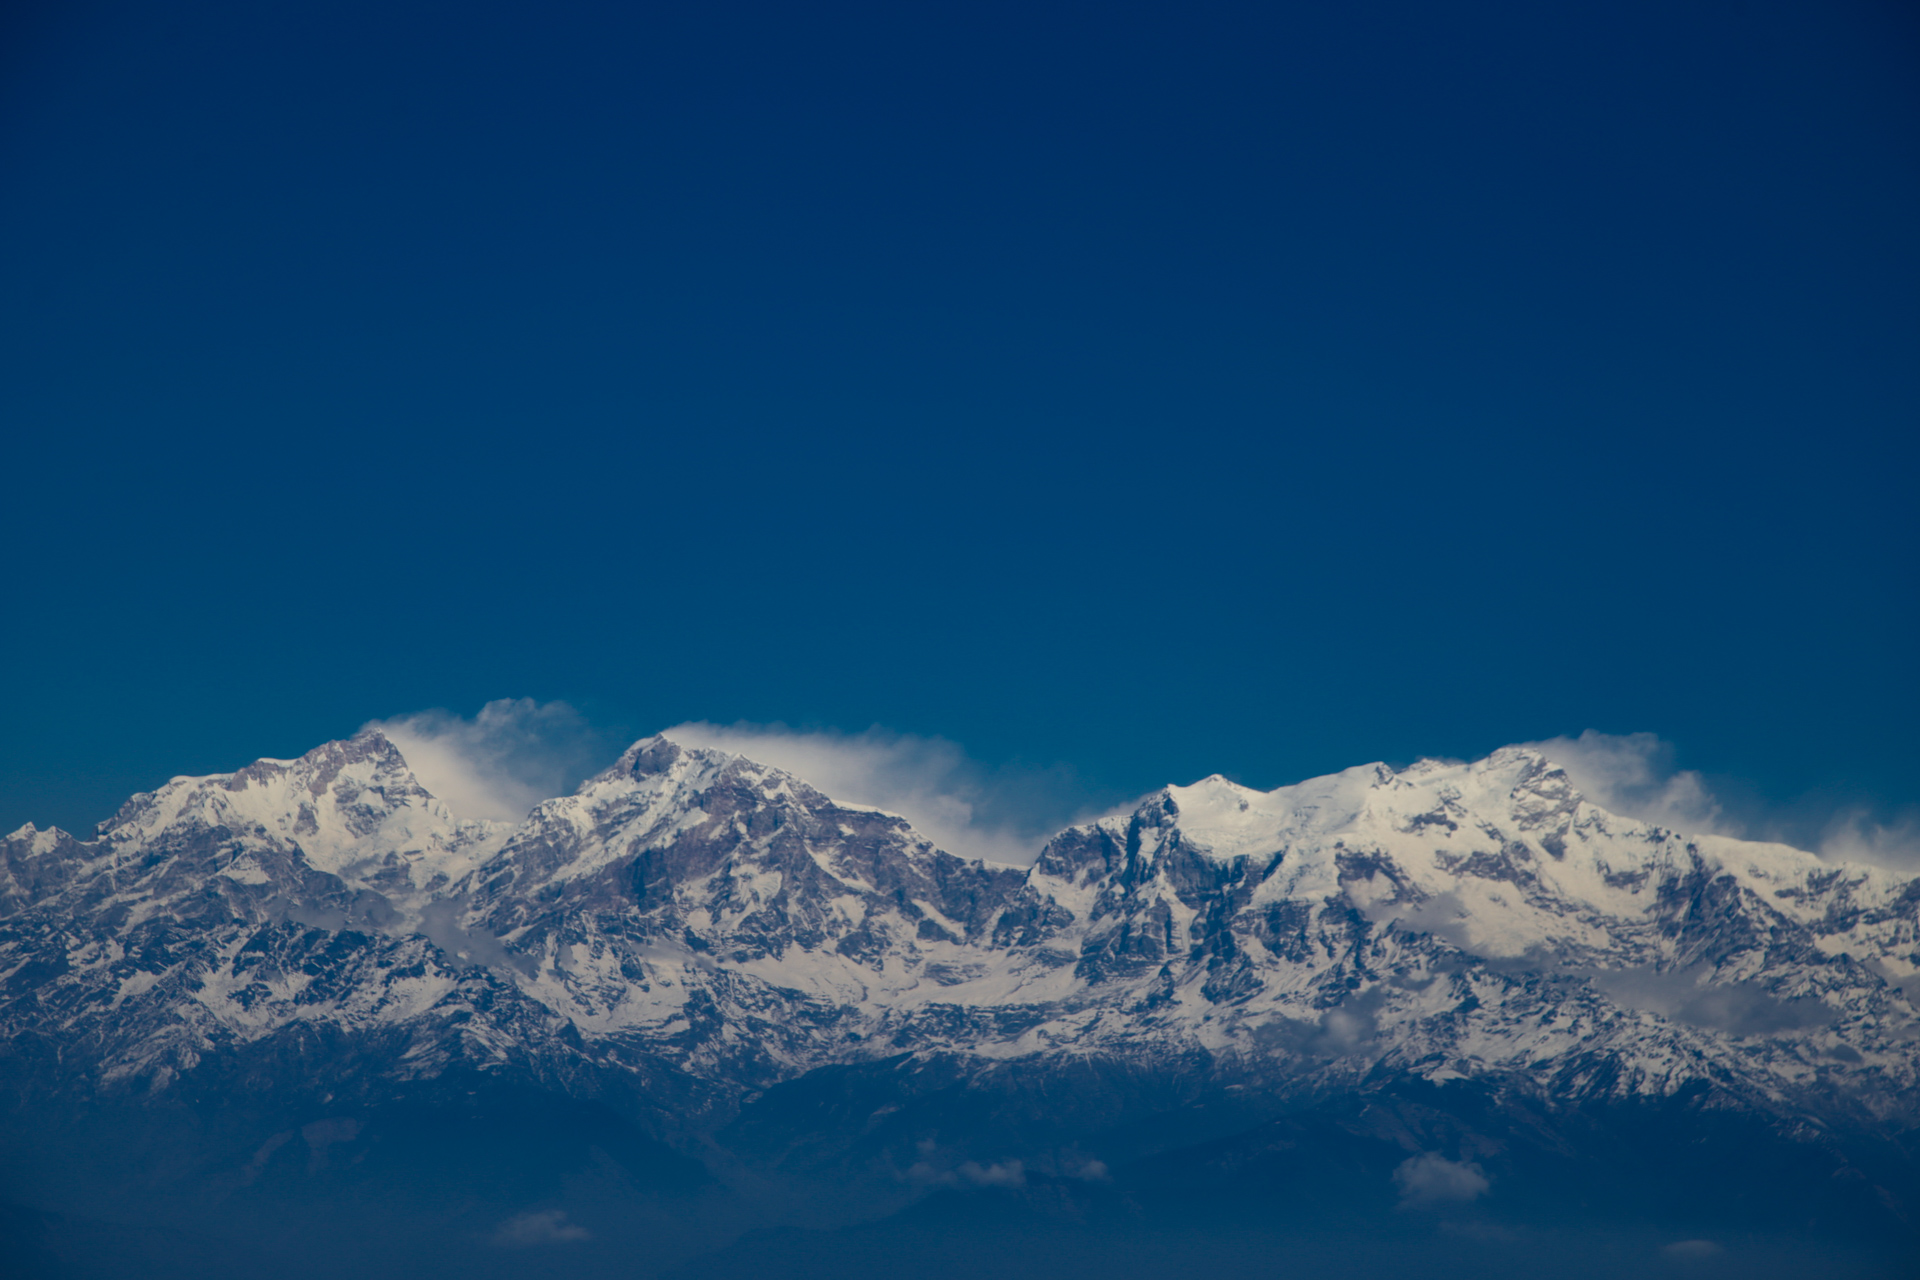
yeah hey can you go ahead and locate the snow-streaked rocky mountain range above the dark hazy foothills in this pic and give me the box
[0,731,1920,1128]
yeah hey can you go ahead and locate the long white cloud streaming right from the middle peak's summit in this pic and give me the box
[666,720,1087,865]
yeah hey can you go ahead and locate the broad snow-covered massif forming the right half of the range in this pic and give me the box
[1006,748,1920,1111]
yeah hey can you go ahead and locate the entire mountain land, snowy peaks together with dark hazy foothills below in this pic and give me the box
[0,731,1920,1278]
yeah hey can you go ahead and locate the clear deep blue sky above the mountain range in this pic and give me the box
[0,0,1920,829]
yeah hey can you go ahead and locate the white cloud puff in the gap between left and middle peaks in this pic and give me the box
[363,699,611,821]
